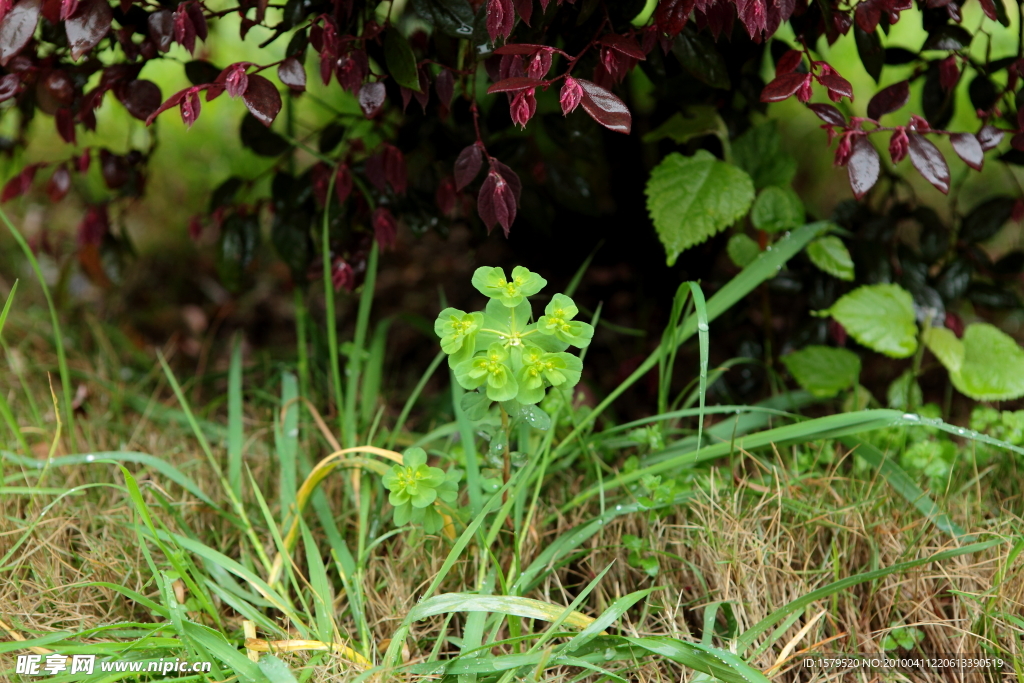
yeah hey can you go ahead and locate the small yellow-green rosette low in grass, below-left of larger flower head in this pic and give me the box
[384,447,461,533]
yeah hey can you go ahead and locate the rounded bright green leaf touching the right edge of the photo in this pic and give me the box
[949,323,1024,400]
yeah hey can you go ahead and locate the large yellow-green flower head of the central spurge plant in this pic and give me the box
[434,266,594,409]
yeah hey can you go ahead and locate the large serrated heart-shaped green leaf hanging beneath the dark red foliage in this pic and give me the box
[647,150,754,265]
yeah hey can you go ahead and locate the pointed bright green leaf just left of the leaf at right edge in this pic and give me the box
[826,285,918,358]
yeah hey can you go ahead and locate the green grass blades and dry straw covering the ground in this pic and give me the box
[0,224,1024,683]
